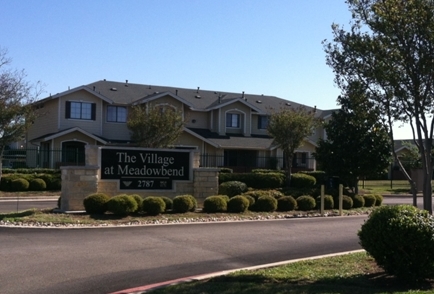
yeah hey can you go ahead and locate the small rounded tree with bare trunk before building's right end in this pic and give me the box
[267,107,318,187]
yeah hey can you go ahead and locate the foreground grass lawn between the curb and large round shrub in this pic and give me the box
[152,252,434,294]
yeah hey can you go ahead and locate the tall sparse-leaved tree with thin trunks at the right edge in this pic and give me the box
[324,0,434,213]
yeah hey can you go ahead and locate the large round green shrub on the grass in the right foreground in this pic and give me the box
[358,205,434,282]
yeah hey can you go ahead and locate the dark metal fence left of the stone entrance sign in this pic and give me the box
[2,148,85,168]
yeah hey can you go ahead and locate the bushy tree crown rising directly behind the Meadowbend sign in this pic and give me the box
[127,103,185,148]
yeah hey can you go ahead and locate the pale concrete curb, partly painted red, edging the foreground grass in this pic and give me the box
[109,249,365,294]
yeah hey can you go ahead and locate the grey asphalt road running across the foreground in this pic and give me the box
[0,216,366,294]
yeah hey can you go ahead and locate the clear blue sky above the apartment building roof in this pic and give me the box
[0,0,411,139]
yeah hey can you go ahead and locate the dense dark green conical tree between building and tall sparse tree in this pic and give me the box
[315,81,392,194]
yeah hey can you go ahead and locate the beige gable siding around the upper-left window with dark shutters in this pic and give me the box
[59,90,103,136]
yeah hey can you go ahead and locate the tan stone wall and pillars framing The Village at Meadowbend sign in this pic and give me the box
[61,145,220,211]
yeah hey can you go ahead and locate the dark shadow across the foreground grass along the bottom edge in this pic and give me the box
[153,273,433,294]
